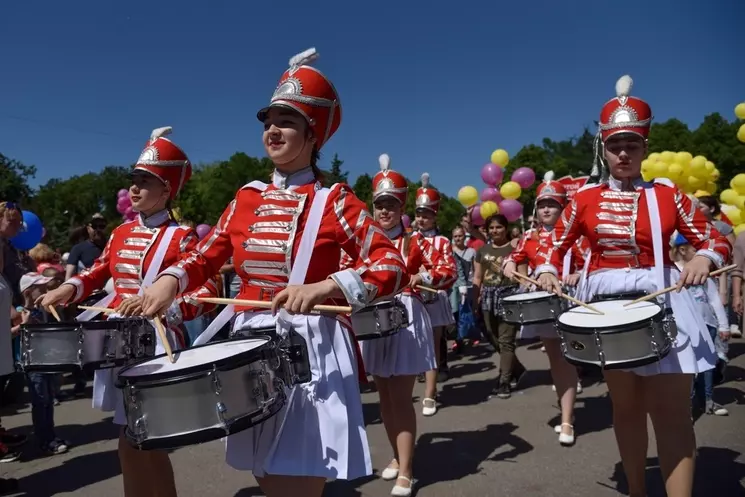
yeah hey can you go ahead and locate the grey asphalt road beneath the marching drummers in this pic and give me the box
[0,340,745,497]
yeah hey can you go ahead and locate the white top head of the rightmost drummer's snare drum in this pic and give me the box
[559,300,662,329]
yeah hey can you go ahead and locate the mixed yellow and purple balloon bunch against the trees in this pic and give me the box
[458,148,535,226]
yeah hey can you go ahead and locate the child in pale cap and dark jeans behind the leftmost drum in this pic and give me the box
[11,273,70,455]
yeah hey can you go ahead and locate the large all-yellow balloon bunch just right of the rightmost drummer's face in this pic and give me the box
[642,150,719,195]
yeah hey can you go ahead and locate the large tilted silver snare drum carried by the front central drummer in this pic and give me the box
[116,336,310,450]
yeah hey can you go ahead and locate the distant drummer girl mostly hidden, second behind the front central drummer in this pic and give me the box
[416,173,457,416]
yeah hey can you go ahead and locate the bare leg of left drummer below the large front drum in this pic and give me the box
[119,429,176,497]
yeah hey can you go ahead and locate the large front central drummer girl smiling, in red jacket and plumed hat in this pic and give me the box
[143,49,409,497]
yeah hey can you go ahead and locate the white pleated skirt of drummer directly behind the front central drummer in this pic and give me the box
[360,295,437,378]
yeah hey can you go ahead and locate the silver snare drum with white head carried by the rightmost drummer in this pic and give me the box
[557,299,677,369]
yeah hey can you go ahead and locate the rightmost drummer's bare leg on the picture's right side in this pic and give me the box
[644,374,696,497]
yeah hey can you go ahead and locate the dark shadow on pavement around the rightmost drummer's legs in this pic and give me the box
[598,447,745,497]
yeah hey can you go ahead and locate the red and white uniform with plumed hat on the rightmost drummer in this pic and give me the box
[536,76,730,375]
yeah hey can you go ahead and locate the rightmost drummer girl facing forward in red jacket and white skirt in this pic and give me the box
[536,76,730,497]
